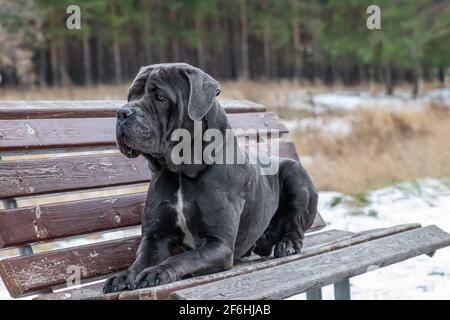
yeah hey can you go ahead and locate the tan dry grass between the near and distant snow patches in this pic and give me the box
[293,108,450,195]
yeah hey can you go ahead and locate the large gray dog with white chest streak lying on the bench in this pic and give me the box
[103,63,317,293]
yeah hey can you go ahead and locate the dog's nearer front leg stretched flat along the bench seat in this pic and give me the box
[134,238,233,289]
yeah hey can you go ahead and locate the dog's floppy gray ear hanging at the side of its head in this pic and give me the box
[185,68,220,121]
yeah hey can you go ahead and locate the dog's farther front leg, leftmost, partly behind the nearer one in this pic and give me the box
[103,235,170,293]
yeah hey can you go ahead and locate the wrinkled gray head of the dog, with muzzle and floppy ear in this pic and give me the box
[116,63,220,172]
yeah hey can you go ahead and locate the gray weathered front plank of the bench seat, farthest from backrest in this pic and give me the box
[170,226,450,300]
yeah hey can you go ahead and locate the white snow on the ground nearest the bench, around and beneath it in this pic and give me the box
[0,179,450,299]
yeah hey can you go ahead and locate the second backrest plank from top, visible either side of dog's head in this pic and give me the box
[0,112,288,152]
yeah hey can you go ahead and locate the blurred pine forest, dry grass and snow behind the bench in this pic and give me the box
[0,0,450,299]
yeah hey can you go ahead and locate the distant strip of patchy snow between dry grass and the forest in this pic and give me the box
[273,88,450,114]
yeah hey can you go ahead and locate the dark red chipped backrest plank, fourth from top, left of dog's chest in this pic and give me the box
[0,192,147,248]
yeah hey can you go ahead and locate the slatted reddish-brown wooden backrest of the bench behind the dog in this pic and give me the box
[0,100,325,297]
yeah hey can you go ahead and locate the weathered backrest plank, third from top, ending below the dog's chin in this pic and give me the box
[0,153,150,199]
